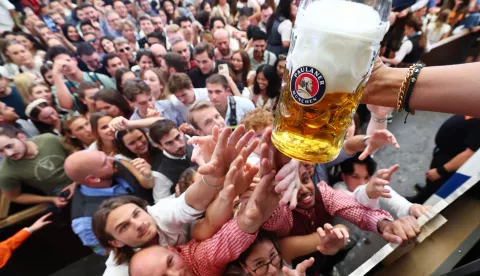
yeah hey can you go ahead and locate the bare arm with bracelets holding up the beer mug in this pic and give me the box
[362,62,480,117]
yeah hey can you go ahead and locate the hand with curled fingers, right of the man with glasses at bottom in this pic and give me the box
[317,223,350,255]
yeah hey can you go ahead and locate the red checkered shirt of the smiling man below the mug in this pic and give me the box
[262,181,393,237]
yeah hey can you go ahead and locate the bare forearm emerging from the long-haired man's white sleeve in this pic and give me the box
[185,176,224,211]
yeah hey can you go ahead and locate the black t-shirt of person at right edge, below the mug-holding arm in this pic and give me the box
[435,115,480,157]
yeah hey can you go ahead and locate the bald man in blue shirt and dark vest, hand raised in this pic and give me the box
[64,150,153,255]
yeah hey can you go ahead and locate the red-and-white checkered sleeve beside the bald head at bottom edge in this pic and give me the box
[169,218,257,276]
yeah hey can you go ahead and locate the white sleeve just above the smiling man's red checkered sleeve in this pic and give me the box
[333,182,413,219]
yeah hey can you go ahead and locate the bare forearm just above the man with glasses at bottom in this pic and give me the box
[278,232,320,263]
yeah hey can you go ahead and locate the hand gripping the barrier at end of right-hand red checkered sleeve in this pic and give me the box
[378,216,420,244]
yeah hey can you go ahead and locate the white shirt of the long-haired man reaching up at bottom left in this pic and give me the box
[103,193,203,276]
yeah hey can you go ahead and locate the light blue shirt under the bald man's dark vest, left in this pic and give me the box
[72,177,133,255]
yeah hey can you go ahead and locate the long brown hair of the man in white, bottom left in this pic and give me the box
[92,196,148,265]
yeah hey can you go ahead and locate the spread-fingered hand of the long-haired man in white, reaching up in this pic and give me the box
[194,125,258,178]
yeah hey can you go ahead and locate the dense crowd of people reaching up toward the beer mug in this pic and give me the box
[0,0,480,276]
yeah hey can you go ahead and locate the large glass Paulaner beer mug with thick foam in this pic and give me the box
[272,0,391,163]
